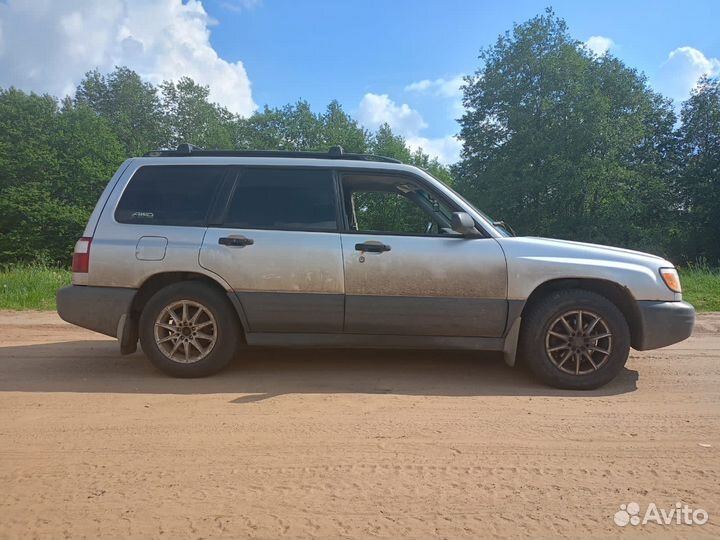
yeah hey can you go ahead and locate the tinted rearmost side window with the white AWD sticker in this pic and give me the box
[115,165,227,227]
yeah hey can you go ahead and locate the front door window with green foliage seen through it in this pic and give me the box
[342,174,455,235]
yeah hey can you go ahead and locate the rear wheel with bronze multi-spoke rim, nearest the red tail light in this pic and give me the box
[139,281,240,378]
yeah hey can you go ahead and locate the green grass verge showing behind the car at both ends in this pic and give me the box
[0,264,720,311]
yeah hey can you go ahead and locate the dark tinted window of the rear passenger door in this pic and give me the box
[224,169,337,231]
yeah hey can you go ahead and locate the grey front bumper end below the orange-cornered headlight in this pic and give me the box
[633,300,695,351]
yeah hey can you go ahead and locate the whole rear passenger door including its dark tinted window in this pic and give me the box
[200,167,344,333]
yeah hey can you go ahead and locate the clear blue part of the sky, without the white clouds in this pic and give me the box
[206,0,720,131]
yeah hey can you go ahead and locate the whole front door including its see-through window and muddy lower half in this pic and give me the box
[341,173,507,337]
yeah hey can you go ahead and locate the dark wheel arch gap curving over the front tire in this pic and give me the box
[521,278,642,347]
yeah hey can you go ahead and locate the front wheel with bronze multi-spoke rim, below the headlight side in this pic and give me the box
[519,289,630,390]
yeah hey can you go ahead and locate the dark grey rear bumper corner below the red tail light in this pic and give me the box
[57,285,137,337]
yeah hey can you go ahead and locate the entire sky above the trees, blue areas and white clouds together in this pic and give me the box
[0,0,720,161]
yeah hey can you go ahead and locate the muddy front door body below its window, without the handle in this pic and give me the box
[342,233,508,337]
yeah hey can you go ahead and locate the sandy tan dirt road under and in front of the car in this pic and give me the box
[0,312,720,539]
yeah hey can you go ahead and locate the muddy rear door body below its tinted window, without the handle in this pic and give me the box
[195,227,344,332]
